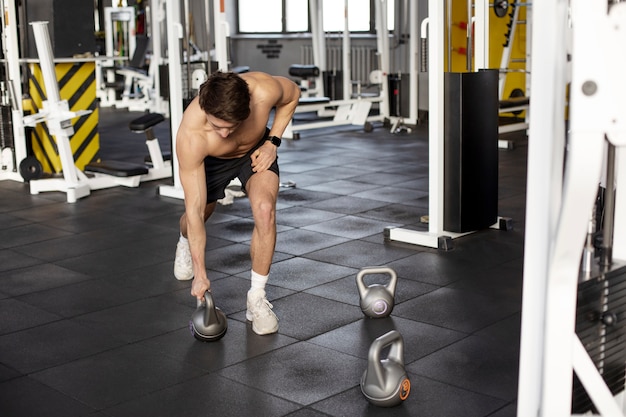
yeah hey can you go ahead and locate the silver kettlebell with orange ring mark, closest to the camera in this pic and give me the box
[361,330,411,407]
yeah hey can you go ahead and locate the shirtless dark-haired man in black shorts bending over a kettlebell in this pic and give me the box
[174,72,300,334]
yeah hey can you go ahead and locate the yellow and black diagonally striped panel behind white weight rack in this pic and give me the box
[25,62,100,173]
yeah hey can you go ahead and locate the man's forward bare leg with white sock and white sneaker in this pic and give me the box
[246,171,278,334]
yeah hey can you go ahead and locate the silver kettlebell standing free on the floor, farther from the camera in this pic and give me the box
[356,266,398,318]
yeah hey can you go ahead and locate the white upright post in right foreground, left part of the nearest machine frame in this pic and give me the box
[518,0,571,417]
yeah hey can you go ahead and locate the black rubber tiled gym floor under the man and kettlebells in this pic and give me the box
[0,105,527,417]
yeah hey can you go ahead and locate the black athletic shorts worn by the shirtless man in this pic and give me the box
[204,129,280,204]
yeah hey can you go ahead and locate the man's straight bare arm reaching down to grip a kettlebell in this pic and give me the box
[176,129,211,300]
